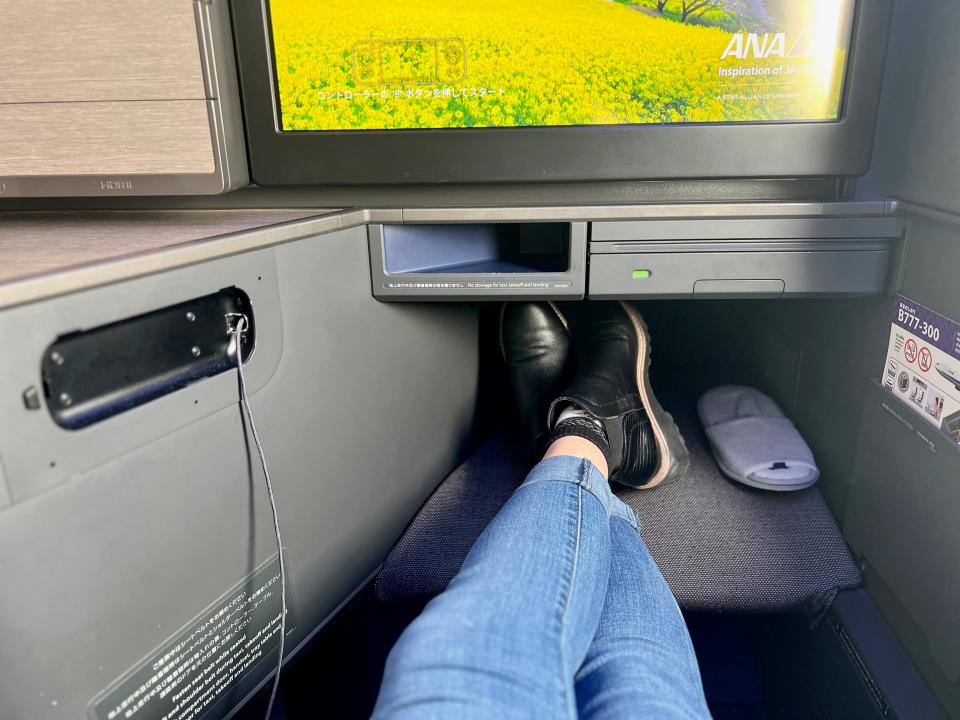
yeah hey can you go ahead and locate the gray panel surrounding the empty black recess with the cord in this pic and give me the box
[0,250,283,502]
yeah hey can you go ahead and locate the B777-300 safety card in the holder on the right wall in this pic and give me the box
[883,295,960,444]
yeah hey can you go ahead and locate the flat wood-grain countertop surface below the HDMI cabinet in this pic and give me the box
[0,210,317,285]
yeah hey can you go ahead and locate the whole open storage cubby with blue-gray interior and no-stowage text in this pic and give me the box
[370,222,586,300]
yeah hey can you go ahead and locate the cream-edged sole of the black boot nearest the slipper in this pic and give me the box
[620,300,690,490]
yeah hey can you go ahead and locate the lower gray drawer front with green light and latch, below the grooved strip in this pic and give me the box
[588,243,890,299]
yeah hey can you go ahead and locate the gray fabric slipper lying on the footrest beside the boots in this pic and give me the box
[697,385,820,491]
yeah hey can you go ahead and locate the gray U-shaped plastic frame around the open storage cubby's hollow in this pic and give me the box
[369,222,587,300]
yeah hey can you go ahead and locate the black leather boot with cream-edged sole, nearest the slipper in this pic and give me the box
[548,302,690,488]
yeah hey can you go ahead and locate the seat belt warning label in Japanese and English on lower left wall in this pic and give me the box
[90,558,290,720]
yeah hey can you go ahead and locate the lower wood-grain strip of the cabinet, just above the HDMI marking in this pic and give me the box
[0,100,214,177]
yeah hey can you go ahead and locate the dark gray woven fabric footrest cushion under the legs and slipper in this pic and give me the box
[376,400,861,615]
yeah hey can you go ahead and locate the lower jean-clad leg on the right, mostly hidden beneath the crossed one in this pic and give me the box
[576,500,710,720]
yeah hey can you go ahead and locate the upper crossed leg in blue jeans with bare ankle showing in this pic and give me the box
[374,437,615,720]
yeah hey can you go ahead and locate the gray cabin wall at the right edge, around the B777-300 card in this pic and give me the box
[860,0,960,717]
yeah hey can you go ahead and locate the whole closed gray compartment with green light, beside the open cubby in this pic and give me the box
[589,217,898,299]
